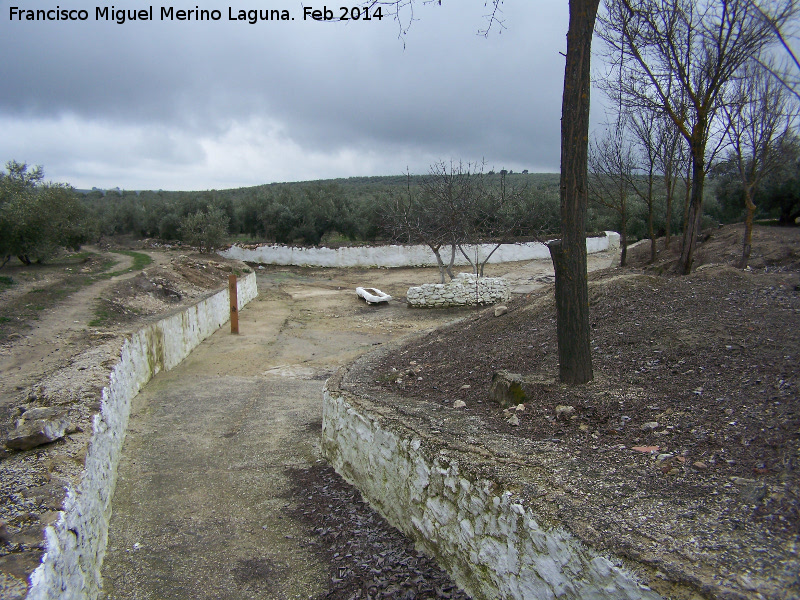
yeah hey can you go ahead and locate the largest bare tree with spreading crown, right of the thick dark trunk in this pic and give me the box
[599,0,795,274]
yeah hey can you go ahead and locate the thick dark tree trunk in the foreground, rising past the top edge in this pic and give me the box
[547,0,599,384]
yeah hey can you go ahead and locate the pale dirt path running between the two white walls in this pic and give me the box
[97,257,613,599]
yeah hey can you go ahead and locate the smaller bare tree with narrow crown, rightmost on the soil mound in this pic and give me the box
[725,59,797,269]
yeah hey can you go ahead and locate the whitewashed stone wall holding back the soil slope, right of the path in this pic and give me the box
[322,384,661,600]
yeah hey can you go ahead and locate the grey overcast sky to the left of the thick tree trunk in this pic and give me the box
[0,0,594,190]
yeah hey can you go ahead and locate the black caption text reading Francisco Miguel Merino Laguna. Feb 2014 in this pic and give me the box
[8,6,383,25]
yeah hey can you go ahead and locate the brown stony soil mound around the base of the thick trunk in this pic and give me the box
[373,227,800,598]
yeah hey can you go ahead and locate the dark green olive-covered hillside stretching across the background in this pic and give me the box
[0,148,800,266]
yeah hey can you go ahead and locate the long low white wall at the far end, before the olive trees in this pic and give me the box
[220,231,619,267]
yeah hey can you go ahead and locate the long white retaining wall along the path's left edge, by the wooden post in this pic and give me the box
[27,273,258,600]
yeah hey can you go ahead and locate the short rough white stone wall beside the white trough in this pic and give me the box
[406,273,511,308]
